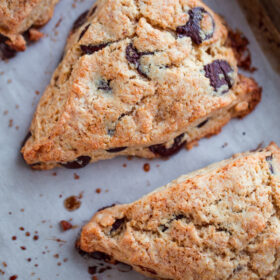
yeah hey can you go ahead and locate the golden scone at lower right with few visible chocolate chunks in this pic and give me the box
[77,144,280,280]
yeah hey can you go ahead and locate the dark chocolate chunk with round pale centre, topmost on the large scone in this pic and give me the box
[176,7,215,45]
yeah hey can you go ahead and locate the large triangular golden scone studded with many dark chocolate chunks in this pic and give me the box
[22,0,261,169]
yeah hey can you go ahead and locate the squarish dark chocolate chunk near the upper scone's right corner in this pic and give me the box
[204,60,233,94]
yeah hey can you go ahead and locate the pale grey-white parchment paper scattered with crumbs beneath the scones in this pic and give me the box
[0,0,280,280]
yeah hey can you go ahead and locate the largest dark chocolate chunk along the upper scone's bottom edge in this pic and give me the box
[149,133,186,157]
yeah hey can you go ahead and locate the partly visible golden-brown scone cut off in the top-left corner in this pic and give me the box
[0,0,59,58]
